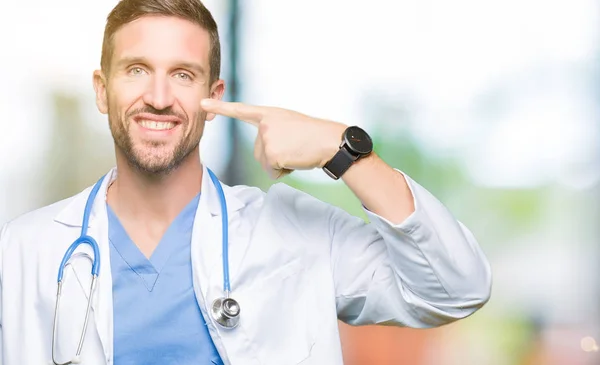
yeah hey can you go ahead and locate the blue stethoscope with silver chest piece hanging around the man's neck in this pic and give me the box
[52,168,240,365]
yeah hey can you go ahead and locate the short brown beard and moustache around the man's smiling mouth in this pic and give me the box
[108,105,200,176]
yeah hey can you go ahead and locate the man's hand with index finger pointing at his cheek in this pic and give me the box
[201,99,347,179]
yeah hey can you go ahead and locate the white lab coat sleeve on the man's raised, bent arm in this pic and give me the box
[330,172,492,328]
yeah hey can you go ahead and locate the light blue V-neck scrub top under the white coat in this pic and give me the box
[107,196,222,365]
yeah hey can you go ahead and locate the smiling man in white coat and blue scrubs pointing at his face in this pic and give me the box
[0,0,491,365]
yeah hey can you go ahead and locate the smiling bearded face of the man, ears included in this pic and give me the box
[94,16,224,174]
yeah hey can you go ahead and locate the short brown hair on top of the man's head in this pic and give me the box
[100,0,221,84]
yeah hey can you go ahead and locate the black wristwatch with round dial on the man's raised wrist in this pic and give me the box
[323,126,373,180]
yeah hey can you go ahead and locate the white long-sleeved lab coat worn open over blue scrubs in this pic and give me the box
[0,169,491,365]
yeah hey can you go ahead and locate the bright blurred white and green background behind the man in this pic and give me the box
[0,0,600,365]
